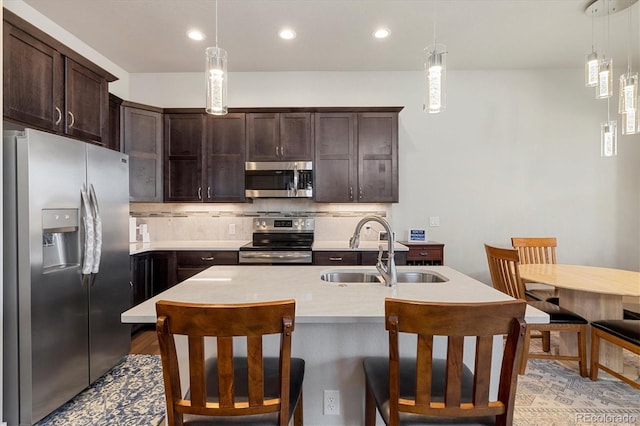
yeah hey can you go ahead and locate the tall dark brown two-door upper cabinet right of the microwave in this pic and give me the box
[314,108,402,203]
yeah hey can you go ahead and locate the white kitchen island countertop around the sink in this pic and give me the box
[121,265,549,323]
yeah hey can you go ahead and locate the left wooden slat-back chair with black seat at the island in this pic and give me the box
[156,300,304,426]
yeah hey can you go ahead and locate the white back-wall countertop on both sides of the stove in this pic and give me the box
[129,239,409,255]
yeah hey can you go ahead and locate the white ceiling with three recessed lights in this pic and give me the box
[20,0,640,73]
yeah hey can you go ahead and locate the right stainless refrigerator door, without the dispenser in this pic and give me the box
[87,145,132,382]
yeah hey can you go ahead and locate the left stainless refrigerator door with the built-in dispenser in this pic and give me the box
[15,129,89,424]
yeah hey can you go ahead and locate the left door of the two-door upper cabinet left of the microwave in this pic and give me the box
[164,114,204,202]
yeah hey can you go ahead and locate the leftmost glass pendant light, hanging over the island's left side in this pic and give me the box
[205,0,228,115]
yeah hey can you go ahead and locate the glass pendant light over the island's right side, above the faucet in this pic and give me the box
[422,1,447,114]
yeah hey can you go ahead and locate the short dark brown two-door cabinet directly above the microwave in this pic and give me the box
[246,112,313,161]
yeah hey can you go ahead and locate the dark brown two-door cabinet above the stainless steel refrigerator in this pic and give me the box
[3,9,117,146]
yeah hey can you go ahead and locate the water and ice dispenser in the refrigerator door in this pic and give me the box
[42,209,80,273]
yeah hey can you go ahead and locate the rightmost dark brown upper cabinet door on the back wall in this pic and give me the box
[358,112,398,203]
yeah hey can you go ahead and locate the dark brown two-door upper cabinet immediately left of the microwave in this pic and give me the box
[164,113,246,202]
